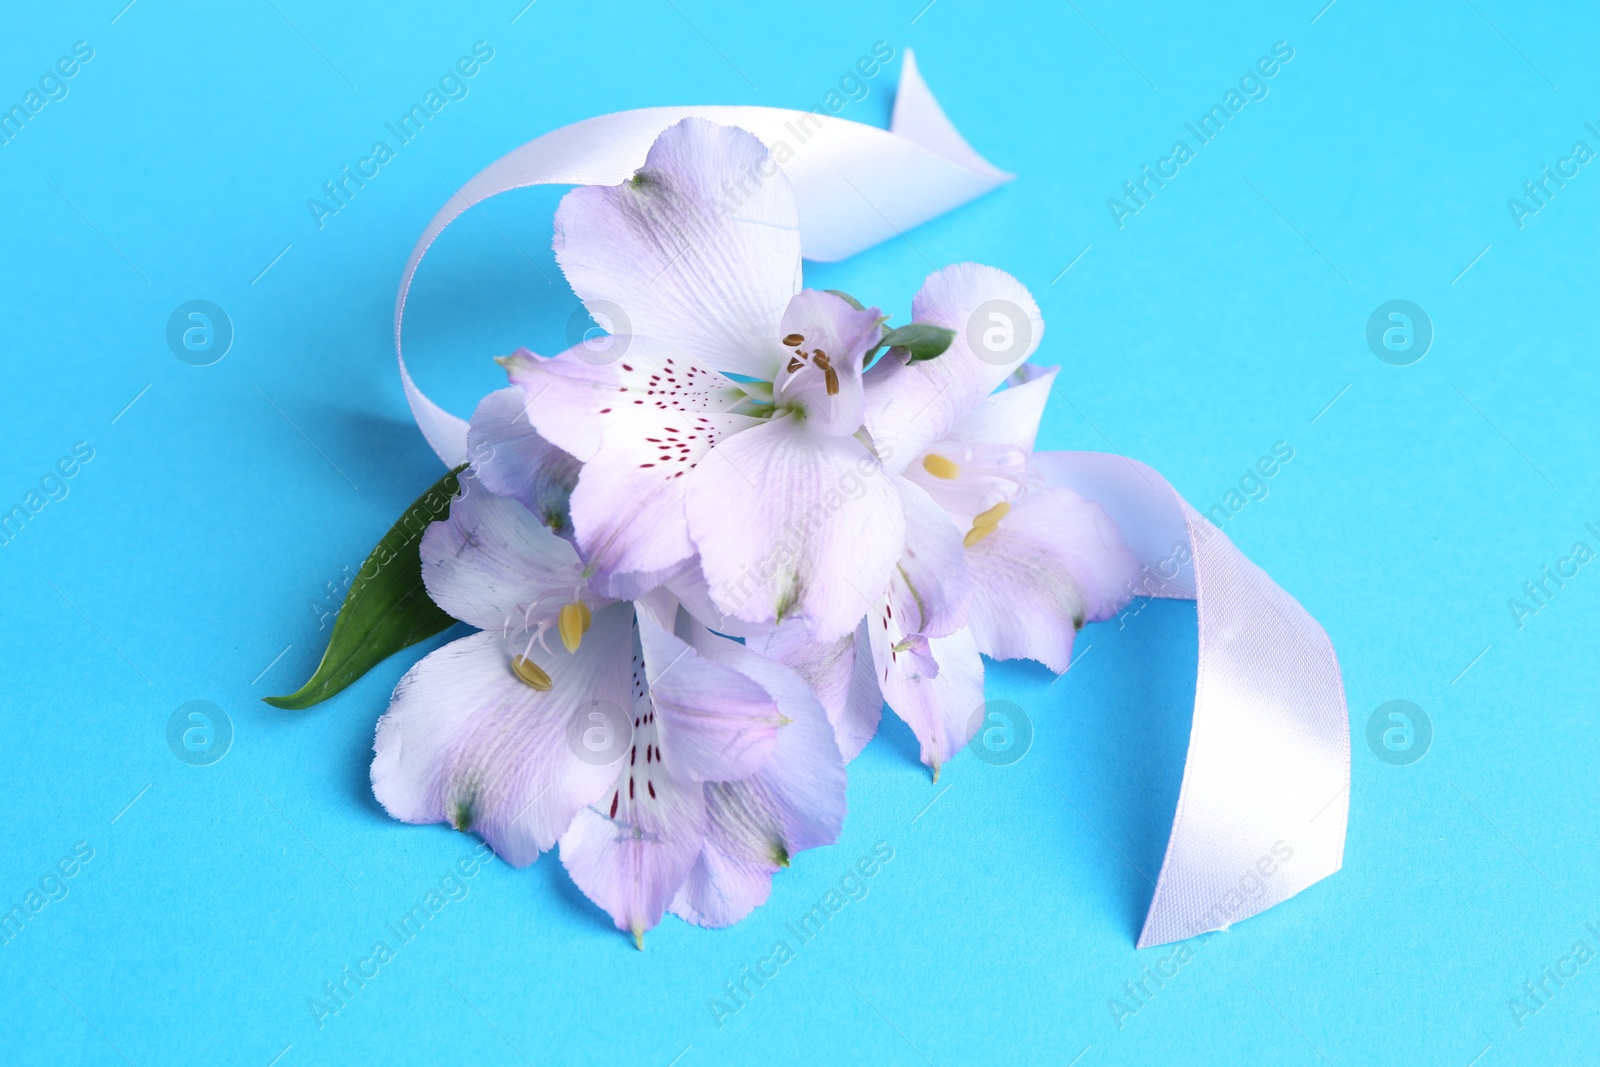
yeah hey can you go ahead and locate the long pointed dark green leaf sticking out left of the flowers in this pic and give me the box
[262,464,466,710]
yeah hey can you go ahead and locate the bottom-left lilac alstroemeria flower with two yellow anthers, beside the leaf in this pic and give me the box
[371,463,845,941]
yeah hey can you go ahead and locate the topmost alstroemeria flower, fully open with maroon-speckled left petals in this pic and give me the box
[502,118,906,640]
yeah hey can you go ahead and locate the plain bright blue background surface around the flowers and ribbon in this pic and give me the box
[0,0,1600,1067]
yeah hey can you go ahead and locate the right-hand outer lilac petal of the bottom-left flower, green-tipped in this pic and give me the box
[672,630,846,926]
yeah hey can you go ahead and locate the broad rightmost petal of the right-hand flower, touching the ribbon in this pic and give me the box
[966,488,1139,673]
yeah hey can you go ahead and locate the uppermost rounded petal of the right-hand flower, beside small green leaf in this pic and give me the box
[866,262,1045,474]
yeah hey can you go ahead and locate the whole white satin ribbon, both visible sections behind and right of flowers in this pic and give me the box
[394,50,1350,949]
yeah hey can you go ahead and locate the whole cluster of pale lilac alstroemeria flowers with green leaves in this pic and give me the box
[272,62,1342,947]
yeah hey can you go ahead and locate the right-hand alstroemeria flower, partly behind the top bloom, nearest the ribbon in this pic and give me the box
[758,264,1136,777]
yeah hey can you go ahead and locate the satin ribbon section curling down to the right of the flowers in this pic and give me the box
[1034,453,1350,949]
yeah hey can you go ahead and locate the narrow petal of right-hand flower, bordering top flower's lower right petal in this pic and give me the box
[890,478,971,637]
